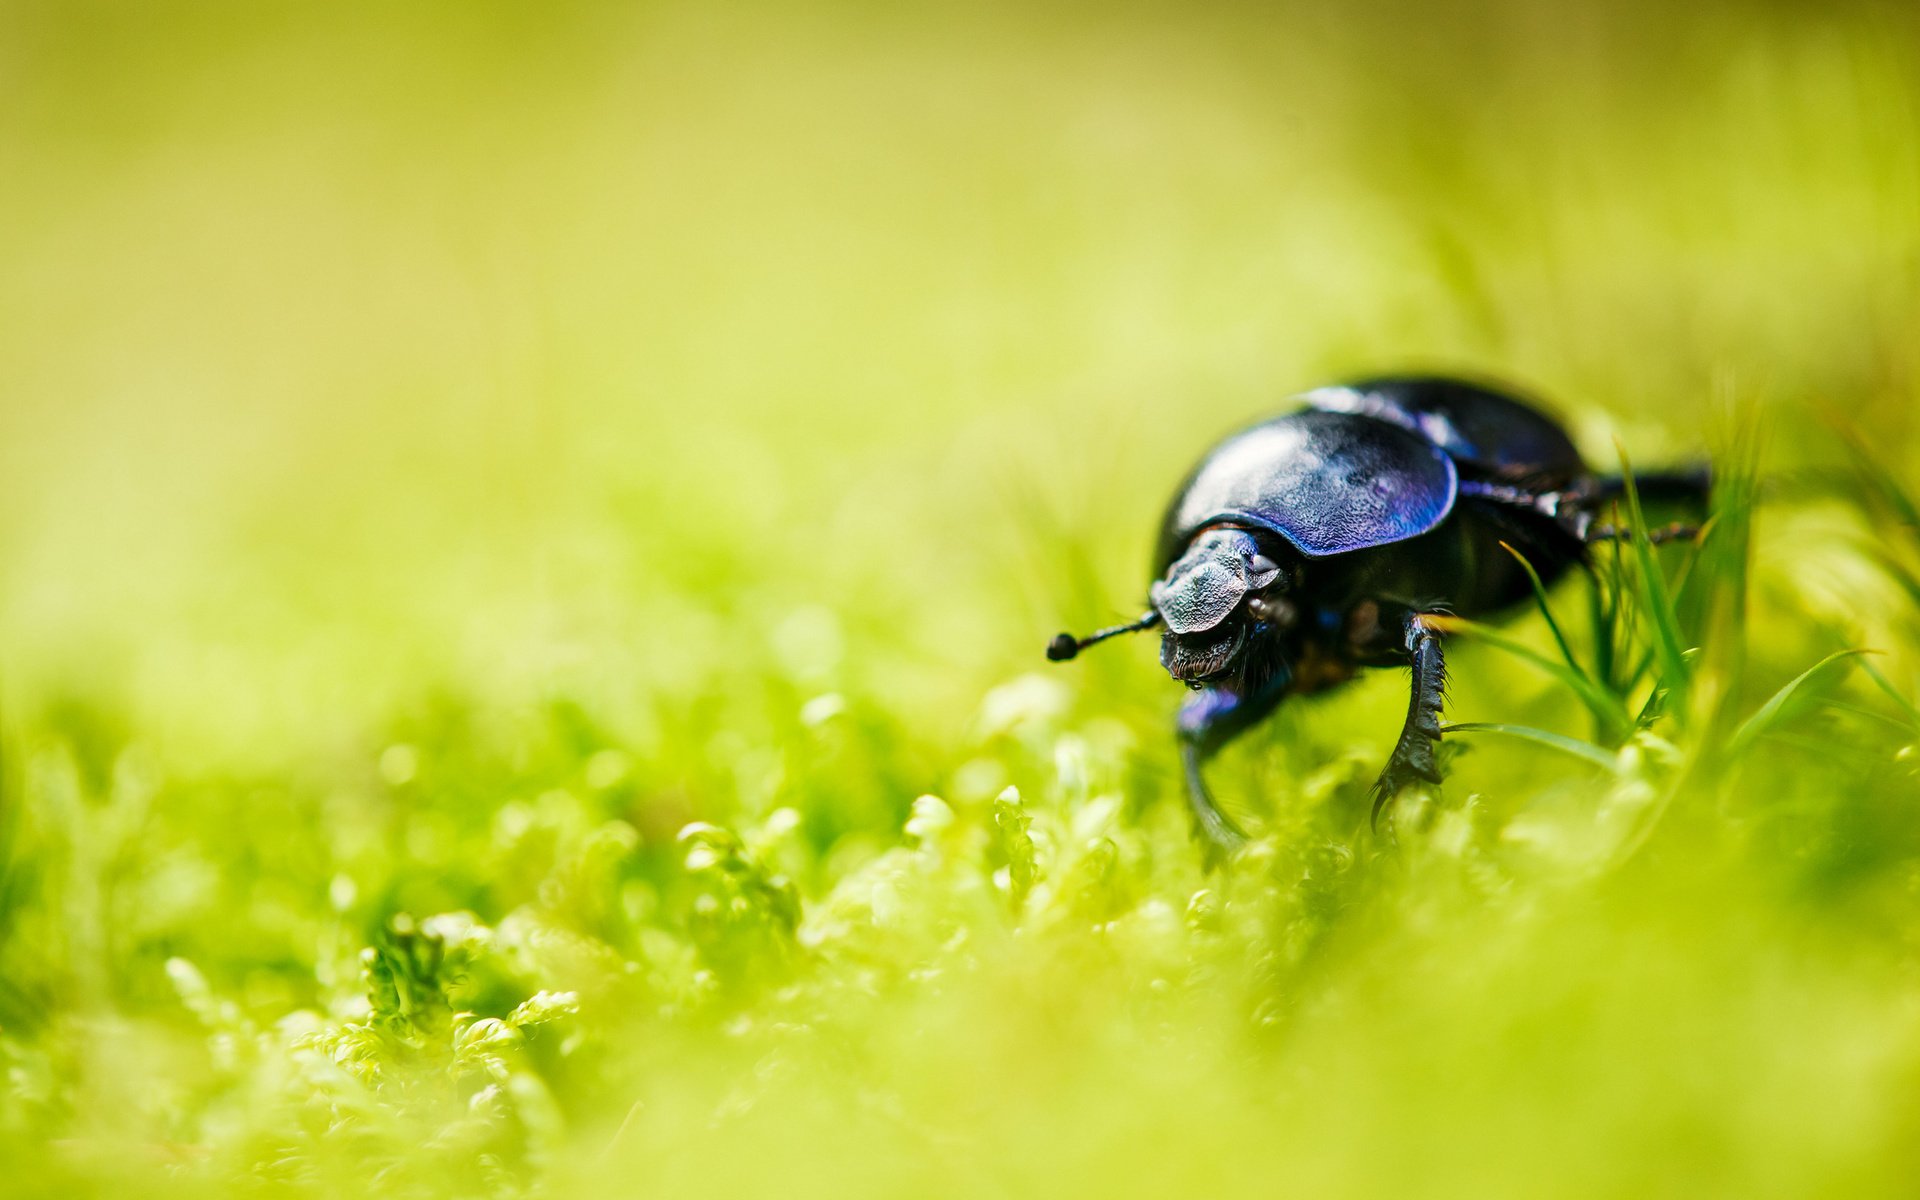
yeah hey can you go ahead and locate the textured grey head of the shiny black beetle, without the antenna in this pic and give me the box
[1150,528,1290,684]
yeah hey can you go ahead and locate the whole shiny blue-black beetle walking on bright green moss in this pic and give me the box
[1046,376,1707,851]
